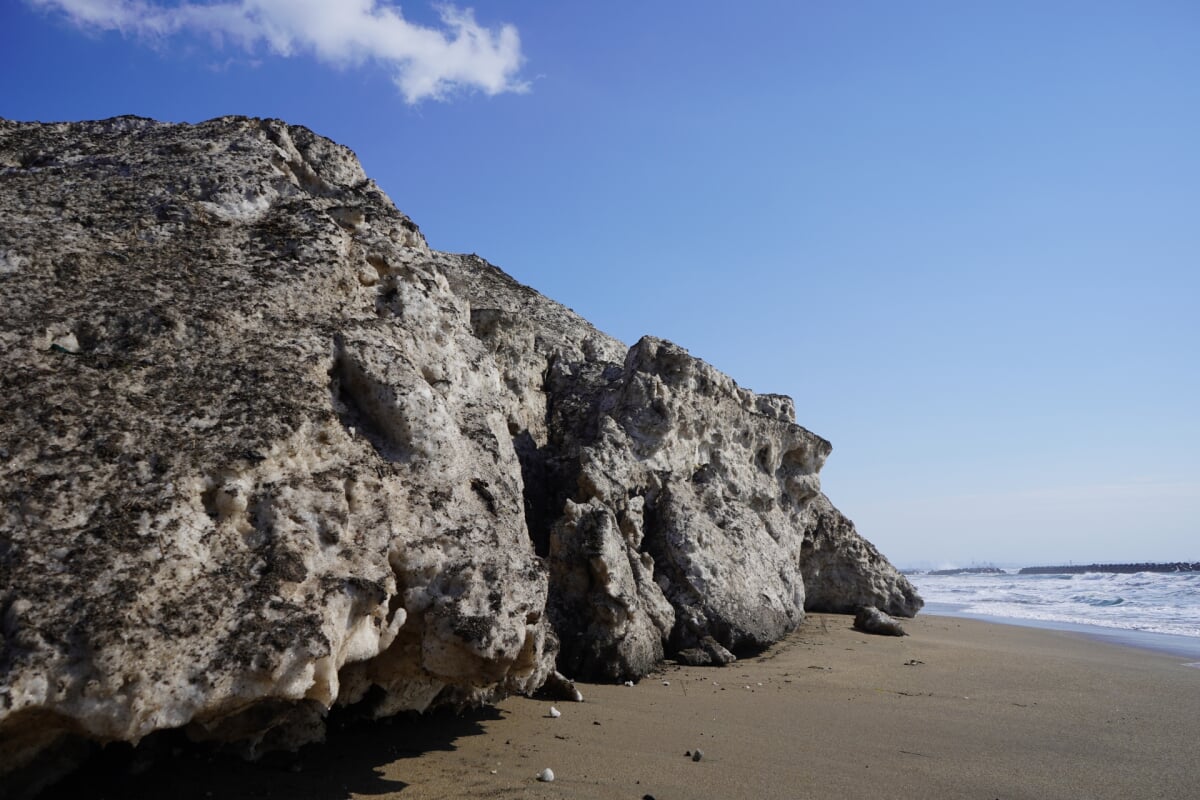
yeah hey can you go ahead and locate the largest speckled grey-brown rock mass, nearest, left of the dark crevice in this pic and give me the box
[0,118,554,786]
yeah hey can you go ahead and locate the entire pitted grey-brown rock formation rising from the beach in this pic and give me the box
[0,118,920,791]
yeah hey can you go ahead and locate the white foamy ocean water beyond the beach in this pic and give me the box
[908,570,1200,658]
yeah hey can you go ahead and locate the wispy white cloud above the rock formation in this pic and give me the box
[28,0,528,103]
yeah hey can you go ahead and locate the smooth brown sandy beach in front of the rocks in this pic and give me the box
[35,615,1200,800]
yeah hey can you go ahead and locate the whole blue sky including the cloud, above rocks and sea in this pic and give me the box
[0,0,1200,565]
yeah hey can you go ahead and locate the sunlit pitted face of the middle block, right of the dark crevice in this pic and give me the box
[551,338,829,674]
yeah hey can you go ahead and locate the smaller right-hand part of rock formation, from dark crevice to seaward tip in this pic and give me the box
[442,257,922,679]
